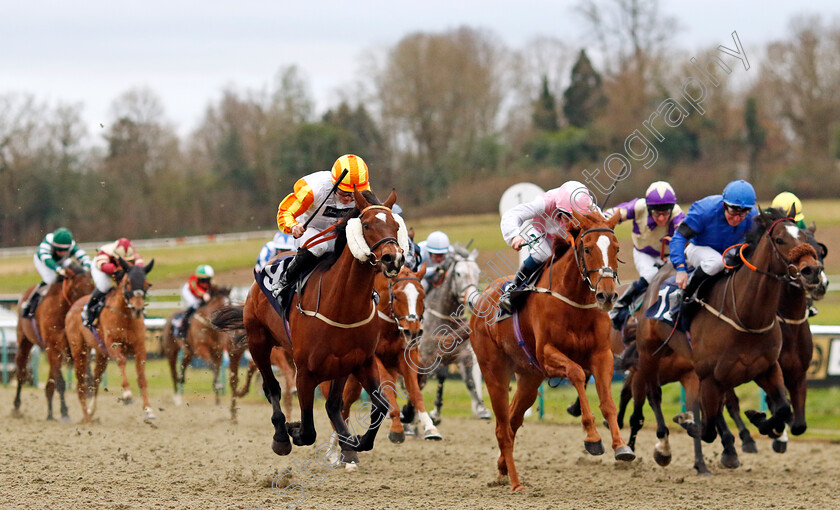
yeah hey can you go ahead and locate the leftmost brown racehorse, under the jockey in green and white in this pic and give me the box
[12,262,93,421]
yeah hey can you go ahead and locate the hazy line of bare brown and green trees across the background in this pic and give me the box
[0,0,840,246]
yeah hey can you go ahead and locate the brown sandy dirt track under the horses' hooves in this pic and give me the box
[0,388,840,510]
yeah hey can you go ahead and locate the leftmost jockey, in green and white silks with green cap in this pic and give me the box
[21,227,90,318]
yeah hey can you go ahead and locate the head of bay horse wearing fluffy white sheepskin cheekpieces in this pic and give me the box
[345,191,409,278]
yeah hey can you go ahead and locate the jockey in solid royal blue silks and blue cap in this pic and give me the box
[671,180,758,299]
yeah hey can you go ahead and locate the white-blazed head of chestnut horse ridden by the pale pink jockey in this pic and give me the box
[569,210,619,312]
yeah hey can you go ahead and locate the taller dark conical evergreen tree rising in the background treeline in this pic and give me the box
[563,50,607,127]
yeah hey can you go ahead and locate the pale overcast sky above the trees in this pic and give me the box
[0,0,840,139]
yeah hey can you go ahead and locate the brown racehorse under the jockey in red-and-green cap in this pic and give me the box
[161,285,236,405]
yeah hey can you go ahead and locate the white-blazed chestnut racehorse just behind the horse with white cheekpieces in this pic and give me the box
[334,264,442,443]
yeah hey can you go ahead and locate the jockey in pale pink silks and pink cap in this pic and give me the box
[499,181,597,313]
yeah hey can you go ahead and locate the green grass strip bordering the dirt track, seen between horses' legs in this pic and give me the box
[14,356,840,440]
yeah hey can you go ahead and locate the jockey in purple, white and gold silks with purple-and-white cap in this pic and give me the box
[604,181,685,330]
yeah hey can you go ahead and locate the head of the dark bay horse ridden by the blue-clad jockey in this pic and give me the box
[747,209,822,292]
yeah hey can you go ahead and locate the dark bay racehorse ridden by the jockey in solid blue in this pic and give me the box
[631,211,820,474]
